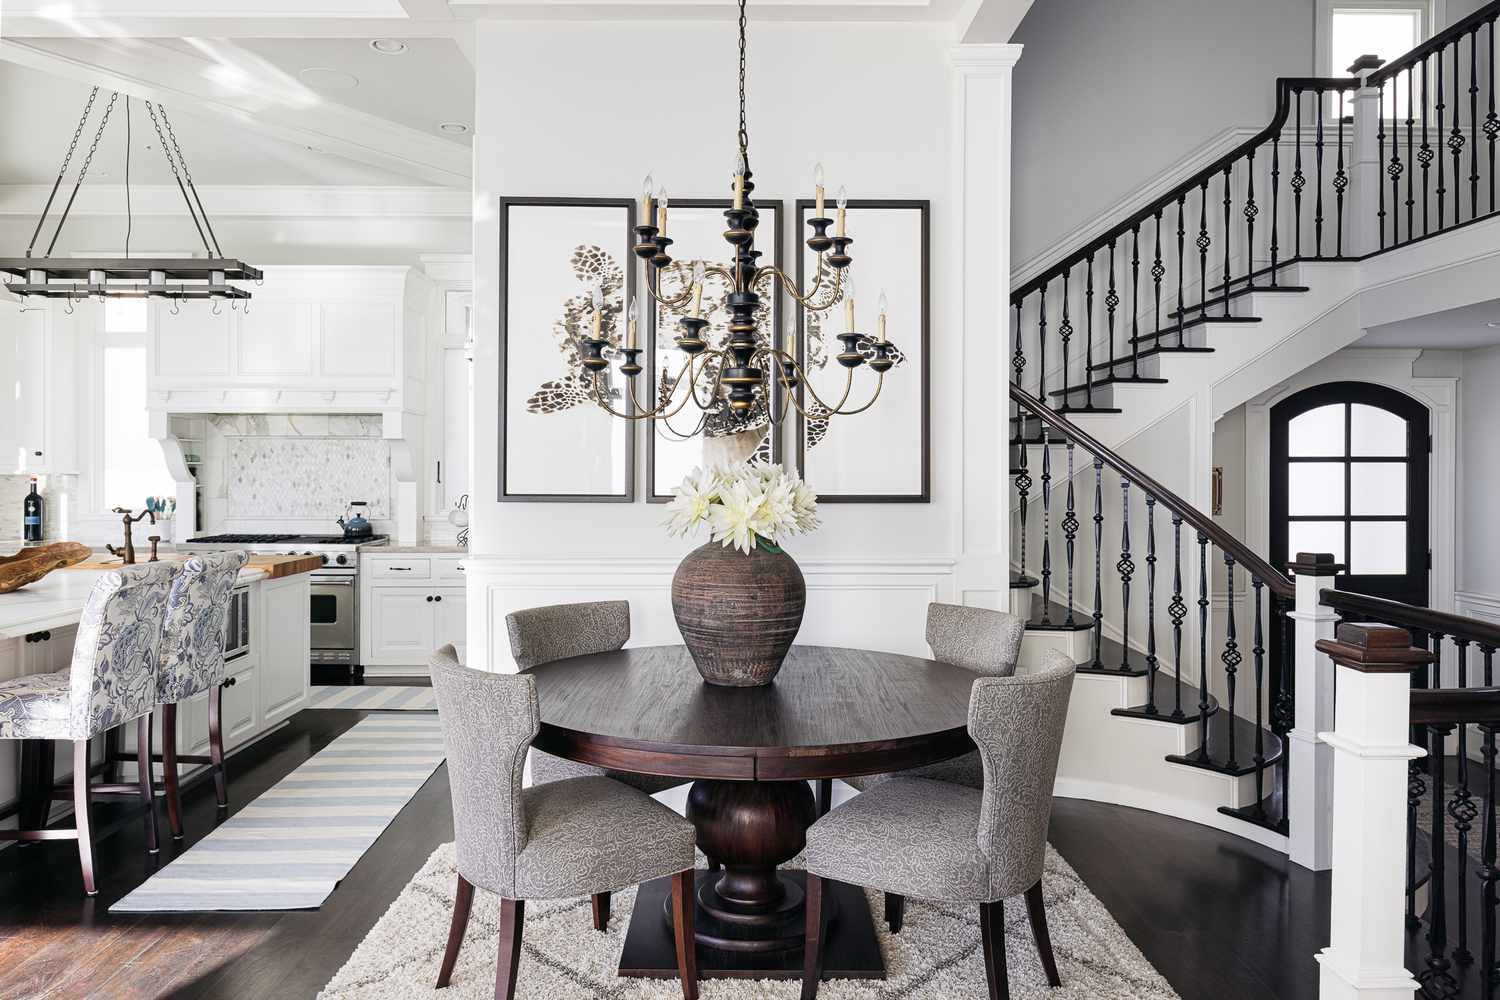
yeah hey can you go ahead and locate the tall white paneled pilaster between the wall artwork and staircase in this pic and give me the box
[950,45,1022,610]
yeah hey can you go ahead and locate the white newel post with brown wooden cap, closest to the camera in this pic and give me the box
[1317,624,1433,1000]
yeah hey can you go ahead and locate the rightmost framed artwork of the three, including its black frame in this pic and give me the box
[797,201,932,504]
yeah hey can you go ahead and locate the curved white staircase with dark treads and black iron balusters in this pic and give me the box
[1010,3,1500,850]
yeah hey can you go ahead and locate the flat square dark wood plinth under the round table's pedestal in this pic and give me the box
[620,870,885,979]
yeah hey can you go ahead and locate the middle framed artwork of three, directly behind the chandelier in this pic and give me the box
[641,198,789,504]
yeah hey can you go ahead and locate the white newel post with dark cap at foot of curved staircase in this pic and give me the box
[1287,552,1344,871]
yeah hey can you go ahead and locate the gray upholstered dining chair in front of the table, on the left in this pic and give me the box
[431,646,698,1000]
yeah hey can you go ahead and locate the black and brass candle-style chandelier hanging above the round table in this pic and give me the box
[581,0,900,439]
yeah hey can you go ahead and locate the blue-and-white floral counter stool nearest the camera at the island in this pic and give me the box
[0,562,176,895]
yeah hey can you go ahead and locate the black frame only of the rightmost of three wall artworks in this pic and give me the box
[795,198,932,504]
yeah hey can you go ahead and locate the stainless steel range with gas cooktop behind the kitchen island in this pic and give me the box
[182,535,390,672]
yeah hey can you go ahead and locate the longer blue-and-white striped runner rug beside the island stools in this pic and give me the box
[110,716,444,913]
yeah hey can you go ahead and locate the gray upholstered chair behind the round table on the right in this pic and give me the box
[840,603,1026,813]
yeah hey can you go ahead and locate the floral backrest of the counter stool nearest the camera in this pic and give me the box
[69,562,177,739]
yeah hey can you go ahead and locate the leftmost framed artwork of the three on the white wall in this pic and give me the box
[498,198,636,504]
